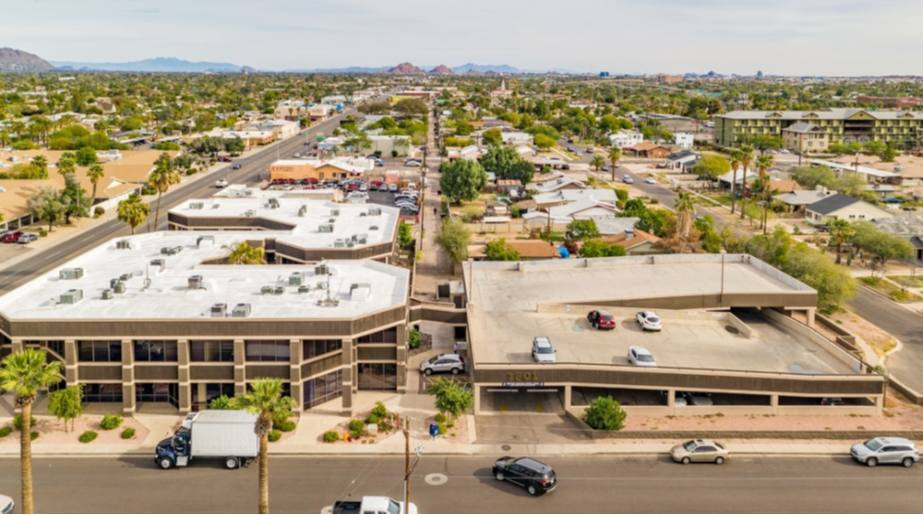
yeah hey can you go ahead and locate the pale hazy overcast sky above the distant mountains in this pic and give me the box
[0,0,923,76]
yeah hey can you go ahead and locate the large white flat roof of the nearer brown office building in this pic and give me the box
[0,231,410,321]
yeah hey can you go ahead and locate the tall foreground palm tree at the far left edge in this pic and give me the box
[0,349,63,513]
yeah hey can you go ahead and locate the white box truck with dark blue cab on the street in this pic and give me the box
[154,410,260,470]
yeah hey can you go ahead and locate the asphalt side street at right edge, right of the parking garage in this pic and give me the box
[849,283,923,393]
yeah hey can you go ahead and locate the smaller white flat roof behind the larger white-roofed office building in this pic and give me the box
[170,195,400,249]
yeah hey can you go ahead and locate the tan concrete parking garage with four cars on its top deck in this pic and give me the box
[466,255,885,416]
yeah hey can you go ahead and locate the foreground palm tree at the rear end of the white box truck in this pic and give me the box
[234,379,295,513]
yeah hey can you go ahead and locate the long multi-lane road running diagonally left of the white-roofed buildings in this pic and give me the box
[0,109,355,295]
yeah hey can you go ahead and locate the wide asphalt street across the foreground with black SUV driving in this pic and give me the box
[0,456,923,513]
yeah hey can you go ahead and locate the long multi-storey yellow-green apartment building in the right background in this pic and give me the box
[715,109,923,149]
